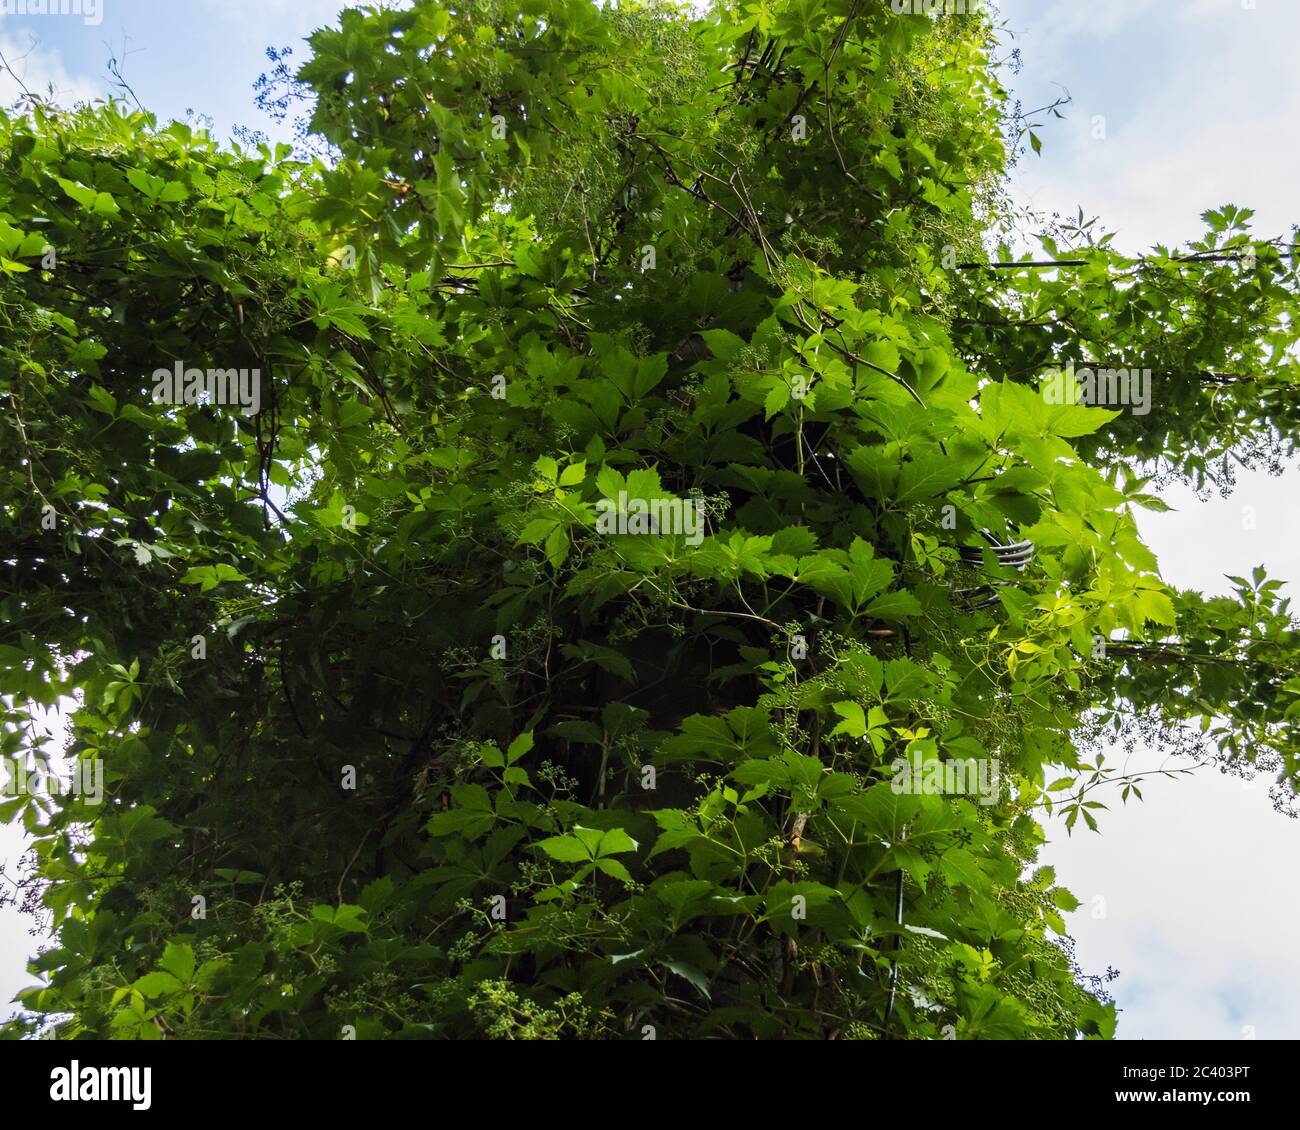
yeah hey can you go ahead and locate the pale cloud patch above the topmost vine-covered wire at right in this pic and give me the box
[1006,0,1300,251]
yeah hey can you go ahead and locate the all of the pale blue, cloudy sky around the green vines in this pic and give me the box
[0,0,1300,1039]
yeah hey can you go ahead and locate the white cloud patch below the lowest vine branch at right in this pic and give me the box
[1044,728,1300,1039]
